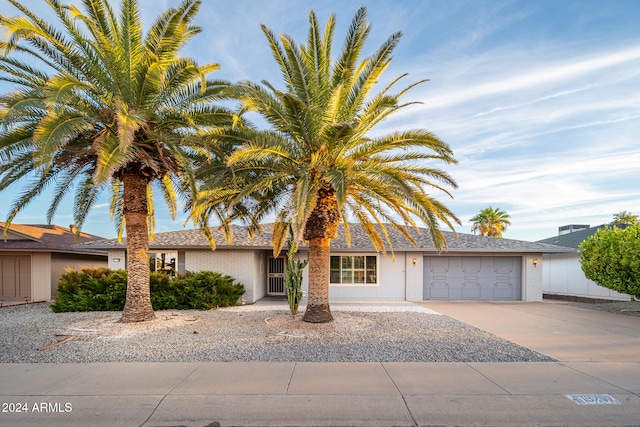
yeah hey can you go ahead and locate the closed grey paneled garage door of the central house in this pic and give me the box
[423,256,522,300]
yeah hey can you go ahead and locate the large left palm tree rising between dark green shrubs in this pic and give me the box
[0,0,238,322]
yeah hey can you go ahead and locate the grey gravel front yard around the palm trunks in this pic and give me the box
[0,303,553,363]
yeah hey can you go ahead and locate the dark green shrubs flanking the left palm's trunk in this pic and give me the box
[51,268,244,313]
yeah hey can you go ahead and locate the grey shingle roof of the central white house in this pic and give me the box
[81,224,572,253]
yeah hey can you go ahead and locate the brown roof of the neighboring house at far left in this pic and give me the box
[0,222,105,255]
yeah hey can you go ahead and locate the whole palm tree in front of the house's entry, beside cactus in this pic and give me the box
[194,8,458,323]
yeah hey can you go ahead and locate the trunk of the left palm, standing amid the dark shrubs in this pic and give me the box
[120,172,155,323]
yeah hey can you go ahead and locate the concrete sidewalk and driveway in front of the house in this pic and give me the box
[0,302,640,427]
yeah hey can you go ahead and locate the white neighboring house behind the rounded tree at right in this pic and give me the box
[538,224,631,301]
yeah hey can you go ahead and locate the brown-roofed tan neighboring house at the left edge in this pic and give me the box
[0,222,107,303]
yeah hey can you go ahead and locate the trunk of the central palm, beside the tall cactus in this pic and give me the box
[302,184,342,323]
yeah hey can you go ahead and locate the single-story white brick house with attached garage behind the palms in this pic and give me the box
[77,224,571,303]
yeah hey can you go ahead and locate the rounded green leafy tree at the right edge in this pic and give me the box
[578,224,640,298]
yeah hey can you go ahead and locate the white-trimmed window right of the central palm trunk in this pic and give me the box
[329,255,378,285]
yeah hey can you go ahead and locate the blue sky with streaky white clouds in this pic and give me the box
[0,0,640,240]
